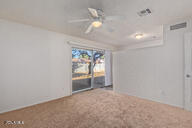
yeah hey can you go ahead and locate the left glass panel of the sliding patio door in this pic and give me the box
[72,48,93,92]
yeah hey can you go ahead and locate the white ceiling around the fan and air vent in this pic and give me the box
[0,0,192,46]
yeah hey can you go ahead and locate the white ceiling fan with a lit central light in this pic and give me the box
[68,8,123,34]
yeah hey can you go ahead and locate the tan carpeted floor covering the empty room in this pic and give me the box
[0,89,192,128]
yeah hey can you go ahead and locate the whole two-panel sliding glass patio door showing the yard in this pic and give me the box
[72,47,105,93]
